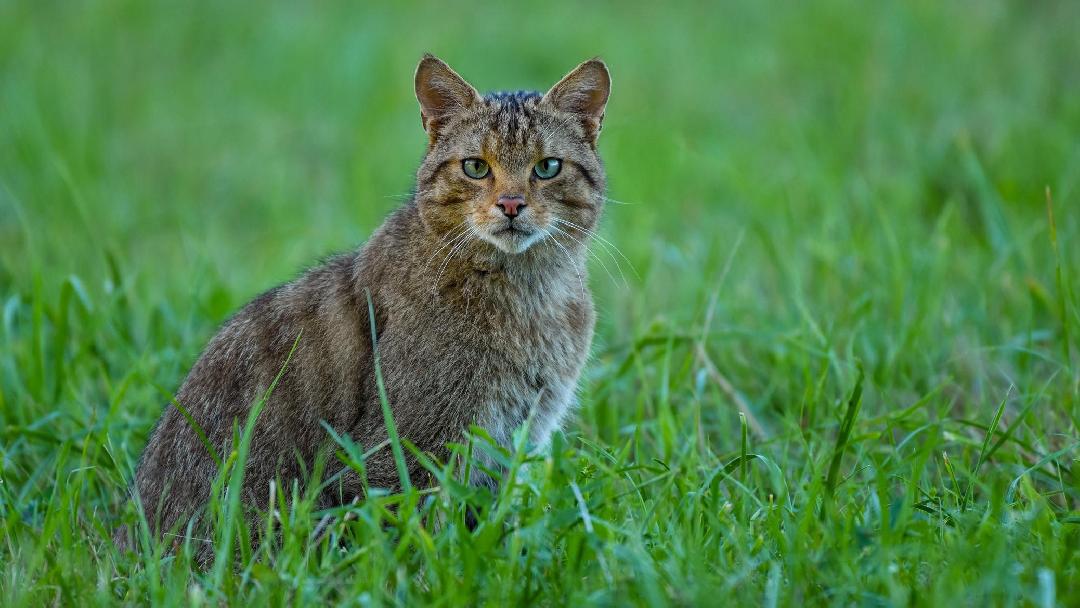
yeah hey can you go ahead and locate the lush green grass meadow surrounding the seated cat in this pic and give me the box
[0,0,1080,606]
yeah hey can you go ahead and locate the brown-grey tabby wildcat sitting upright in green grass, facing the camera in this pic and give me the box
[116,55,610,557]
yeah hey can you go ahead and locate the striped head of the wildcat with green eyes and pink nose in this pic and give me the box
[416,55,611,254]
